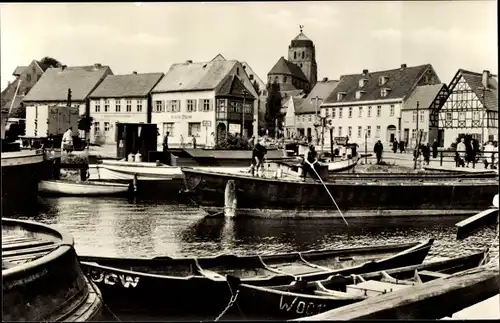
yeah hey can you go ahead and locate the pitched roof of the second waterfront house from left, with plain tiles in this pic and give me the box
[90,73,163,98]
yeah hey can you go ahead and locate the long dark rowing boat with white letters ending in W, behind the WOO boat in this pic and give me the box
[80,239,433,318]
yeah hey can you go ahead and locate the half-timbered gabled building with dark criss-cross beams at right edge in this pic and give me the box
[439,69,498,147]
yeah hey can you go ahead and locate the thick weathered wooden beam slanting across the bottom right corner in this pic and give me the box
[297,265,500,321]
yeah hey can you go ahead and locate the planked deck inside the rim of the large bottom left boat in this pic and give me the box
[2,229,61,270]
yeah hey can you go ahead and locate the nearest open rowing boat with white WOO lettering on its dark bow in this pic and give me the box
[228,251,487,320]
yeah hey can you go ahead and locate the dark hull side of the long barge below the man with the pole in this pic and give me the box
[182,168,498,216]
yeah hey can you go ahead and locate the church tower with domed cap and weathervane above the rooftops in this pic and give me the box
[288,26,318,89]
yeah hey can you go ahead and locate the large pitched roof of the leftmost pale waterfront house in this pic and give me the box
[23,65,113,101]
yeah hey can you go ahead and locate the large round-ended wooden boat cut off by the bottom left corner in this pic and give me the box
[2,218,103,322]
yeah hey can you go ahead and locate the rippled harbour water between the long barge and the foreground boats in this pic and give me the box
[3,197,498,258]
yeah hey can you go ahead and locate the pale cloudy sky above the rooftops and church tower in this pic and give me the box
[0,1,498,89]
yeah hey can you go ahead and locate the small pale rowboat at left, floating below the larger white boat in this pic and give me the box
[38,180,130,196]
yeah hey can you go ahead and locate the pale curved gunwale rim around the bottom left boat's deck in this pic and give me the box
[2,218,74,282]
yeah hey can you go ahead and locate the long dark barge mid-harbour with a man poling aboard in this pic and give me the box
[182,167,498,217]
